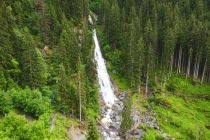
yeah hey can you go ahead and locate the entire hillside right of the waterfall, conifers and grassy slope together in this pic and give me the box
[91,0,210,139]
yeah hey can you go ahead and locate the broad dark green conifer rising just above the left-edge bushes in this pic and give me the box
[15,28,47,88]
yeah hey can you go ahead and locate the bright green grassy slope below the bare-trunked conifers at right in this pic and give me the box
[151,77,210,140]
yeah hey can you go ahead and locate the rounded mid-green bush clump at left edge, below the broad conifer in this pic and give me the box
[0,88,51,118]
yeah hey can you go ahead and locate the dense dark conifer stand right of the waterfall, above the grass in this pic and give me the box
[94,0,210,92]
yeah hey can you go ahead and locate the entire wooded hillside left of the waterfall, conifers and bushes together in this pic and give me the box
[0,0,98,140]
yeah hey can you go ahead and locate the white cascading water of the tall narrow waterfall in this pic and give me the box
[89,16,119,140]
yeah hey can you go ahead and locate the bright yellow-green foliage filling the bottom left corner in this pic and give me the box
[0,113,49,140]
